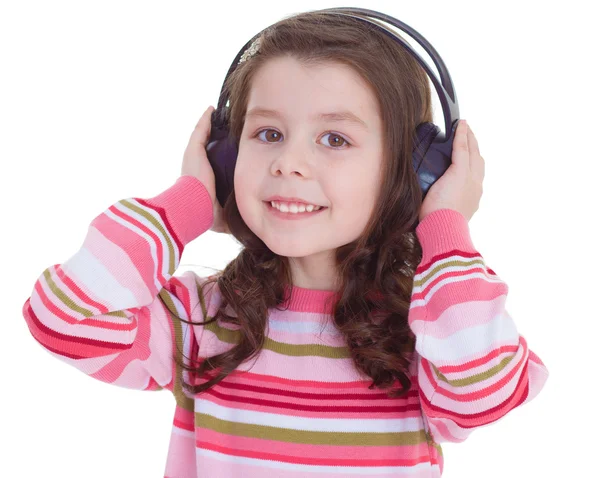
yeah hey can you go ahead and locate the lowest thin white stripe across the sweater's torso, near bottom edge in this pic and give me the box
[196,447,440,478]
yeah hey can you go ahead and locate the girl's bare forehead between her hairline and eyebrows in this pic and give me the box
[247,56,379,125]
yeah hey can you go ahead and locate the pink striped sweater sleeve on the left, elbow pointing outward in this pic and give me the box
[23,176,213,391]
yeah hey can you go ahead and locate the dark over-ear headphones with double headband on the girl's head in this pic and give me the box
[206,7,459,207]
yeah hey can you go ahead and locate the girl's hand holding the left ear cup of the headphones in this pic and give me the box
[181,106,231,234]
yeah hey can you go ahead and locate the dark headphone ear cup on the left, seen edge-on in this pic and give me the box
[206,107,238,207]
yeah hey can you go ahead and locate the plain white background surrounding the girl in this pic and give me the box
[0,0,600,478]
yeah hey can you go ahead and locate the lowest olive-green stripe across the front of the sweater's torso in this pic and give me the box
[194,413,427,446]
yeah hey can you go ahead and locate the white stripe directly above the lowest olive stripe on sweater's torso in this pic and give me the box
[195,397,424,433]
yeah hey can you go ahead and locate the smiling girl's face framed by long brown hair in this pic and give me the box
[234,57,383,286]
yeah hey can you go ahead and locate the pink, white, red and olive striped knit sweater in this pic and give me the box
[23,176,548,478]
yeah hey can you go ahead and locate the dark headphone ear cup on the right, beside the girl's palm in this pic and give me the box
[412,120,459,198]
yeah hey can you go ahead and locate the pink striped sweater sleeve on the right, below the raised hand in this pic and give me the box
[408,209,548,443]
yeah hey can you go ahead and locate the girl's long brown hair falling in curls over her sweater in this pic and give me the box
[175,11,433,397]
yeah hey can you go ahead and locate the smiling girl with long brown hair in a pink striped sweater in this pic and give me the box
[23,8,548,478]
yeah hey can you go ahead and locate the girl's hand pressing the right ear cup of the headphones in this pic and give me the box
[419,120,485,222]
